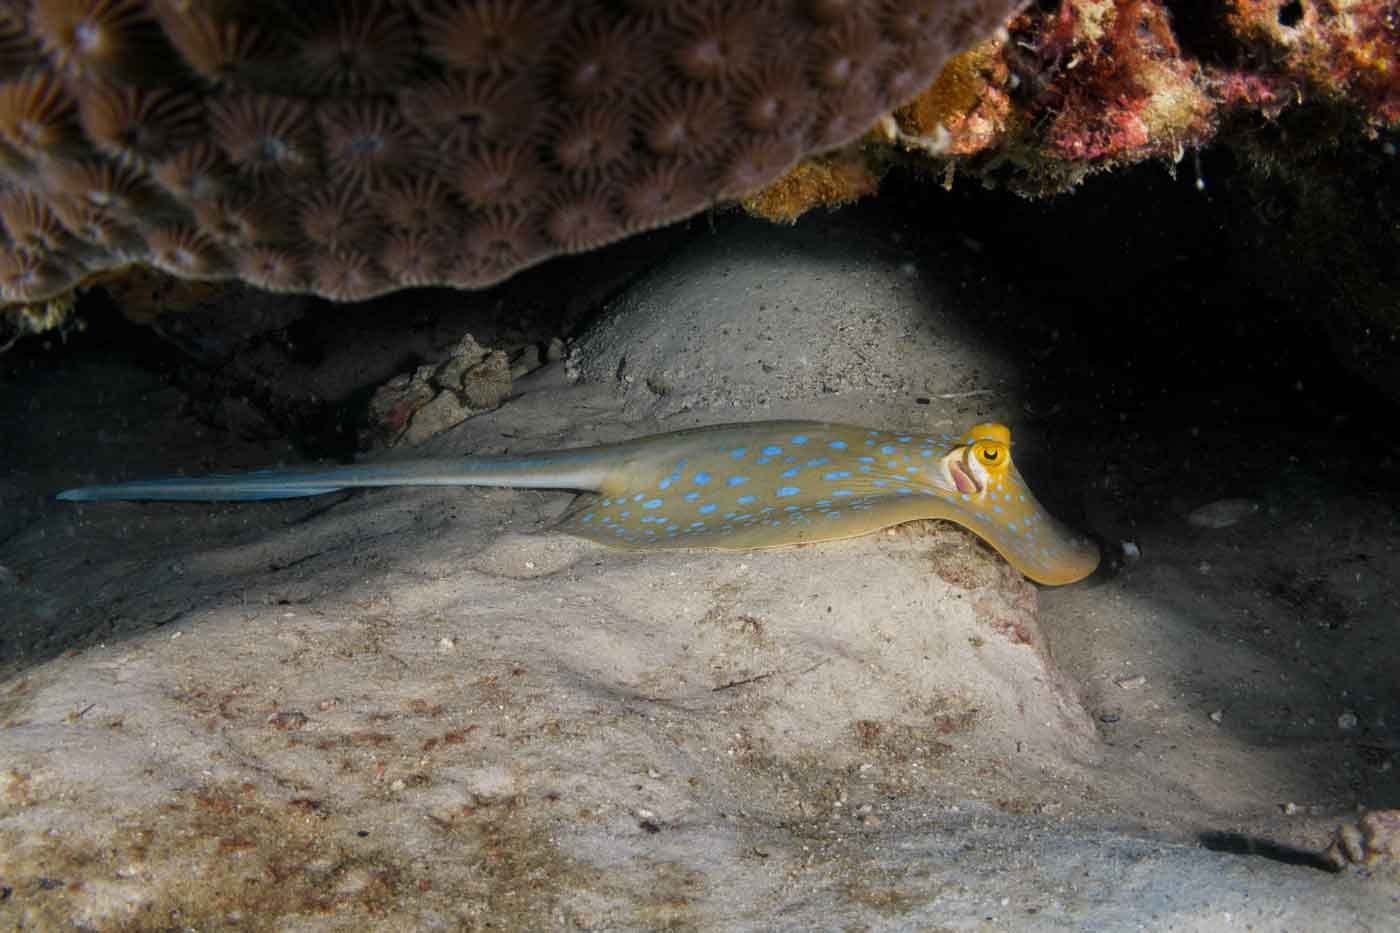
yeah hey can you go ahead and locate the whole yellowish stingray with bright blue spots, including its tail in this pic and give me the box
[59,422,1099,586]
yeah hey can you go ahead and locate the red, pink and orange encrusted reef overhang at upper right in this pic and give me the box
[886,0,1400,195]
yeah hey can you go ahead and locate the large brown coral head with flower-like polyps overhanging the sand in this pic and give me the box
[0,0,1015,303]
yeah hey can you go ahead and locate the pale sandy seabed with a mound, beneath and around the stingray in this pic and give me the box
[0,207,1400,930]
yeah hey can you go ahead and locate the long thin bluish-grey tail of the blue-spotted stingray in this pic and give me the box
[57,448,605,502]
